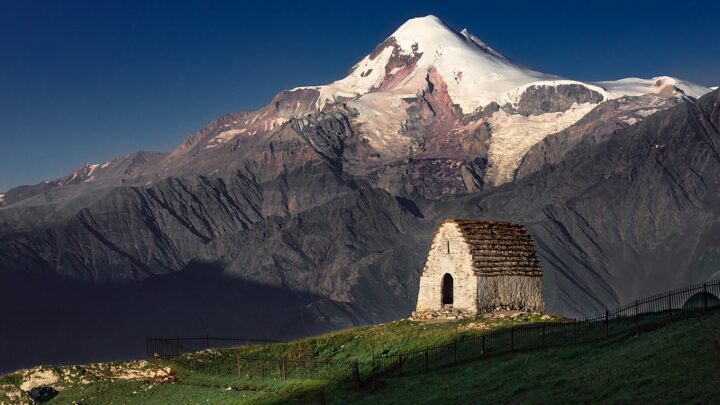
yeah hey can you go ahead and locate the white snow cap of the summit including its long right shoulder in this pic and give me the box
[313,15,710,114]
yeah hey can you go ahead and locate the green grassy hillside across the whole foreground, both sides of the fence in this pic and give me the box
[0,313,720,404]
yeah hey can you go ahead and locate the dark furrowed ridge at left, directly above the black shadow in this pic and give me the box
[0,162,366,281]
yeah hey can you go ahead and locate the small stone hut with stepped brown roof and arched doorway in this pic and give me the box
[414,219,544,318]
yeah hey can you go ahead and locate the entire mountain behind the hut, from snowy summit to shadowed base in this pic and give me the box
[0,16,720,367]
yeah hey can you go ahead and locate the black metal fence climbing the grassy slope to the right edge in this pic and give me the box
[370,280,720,376]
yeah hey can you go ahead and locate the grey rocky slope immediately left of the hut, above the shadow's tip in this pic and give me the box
[197,190,429,322]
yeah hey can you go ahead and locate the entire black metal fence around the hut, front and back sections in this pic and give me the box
[148,280,720,384]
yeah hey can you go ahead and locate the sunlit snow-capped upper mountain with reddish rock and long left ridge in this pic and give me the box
[0,16,710,202]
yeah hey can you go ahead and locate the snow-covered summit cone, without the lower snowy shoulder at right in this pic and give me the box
[317,16,558,113]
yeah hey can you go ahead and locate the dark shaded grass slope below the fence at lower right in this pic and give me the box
[330,313,720,404]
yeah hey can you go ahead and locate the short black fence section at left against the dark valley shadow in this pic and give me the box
[147,336,281,358]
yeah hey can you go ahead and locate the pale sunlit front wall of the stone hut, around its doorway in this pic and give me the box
[417,222,477,314]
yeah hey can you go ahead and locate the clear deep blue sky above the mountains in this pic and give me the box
[0,0,720,191]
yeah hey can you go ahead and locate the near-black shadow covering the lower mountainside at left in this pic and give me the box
[0,263,354,372]
